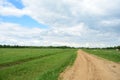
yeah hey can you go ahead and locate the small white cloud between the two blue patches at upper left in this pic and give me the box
[0,0,29,16]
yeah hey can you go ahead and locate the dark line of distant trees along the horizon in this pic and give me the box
[0,45,120,50]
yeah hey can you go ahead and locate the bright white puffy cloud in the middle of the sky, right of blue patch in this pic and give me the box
[47,23,88,36]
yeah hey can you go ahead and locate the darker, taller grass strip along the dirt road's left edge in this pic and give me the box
[37,50,76,80]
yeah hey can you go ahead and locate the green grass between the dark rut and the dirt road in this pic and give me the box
[0,49,76,80]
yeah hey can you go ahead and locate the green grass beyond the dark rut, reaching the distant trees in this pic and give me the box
[0,48,66,64]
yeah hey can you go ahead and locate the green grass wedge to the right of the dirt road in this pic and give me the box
[84,49,120,62]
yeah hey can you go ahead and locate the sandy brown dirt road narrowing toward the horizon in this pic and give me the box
[60,50,120,80]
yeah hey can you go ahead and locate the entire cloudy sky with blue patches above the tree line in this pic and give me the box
[0,0,120,47]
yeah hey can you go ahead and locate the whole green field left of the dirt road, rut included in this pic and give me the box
[0,48,77,80]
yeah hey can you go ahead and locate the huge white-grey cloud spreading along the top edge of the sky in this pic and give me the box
[22,0,120,27]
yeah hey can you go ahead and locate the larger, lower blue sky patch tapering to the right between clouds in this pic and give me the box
[0,15,47,28]
